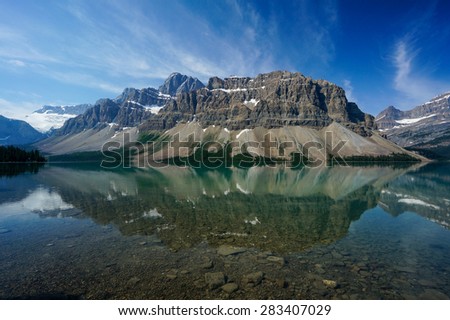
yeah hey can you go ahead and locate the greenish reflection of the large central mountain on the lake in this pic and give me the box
[25,167,414,253]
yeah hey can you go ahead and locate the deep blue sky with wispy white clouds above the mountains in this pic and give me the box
[0,0,450,118]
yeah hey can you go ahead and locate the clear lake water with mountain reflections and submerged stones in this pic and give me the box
[0,164,450,299]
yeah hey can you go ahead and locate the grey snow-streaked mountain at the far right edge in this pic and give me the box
[375,92,450,158]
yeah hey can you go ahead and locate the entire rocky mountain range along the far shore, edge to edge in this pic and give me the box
[5,71,450,161]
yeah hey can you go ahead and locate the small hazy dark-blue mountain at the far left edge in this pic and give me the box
[0,115,45,145]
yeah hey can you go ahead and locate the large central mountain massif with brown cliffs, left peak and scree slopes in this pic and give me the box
[37,71,422,161]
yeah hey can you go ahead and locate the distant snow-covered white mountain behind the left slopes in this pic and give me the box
[25,104,92,133]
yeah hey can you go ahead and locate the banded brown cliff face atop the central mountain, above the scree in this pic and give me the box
[141,71,375,135]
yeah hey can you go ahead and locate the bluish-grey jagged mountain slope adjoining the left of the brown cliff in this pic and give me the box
[37,73,203,154]
